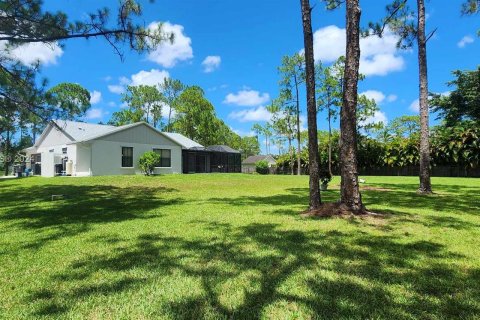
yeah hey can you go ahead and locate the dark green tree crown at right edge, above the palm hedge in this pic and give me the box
[430,66,480,126]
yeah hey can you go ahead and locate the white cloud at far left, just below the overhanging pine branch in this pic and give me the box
[0,41,63,66]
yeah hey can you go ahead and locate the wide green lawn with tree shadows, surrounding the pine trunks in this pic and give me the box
[0,174,480,319]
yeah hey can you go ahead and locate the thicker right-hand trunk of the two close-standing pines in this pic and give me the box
[340,0,365,213]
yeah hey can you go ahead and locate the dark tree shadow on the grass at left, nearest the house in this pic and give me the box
[0,185,180,249]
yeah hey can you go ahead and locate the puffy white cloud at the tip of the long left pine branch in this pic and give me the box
[148,22,193,68]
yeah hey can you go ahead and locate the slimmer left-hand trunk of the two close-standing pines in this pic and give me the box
[300,0,322,210]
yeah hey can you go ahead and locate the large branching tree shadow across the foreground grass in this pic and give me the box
[25,221,480,319]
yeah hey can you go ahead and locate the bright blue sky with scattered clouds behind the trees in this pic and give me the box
[13,0,480,150]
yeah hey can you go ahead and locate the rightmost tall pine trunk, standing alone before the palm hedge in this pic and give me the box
[417,0,432,194]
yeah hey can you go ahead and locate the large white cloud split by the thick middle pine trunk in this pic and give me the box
[313,25,405,76]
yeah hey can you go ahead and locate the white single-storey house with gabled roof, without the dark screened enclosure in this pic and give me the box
[23,121,203,177]
